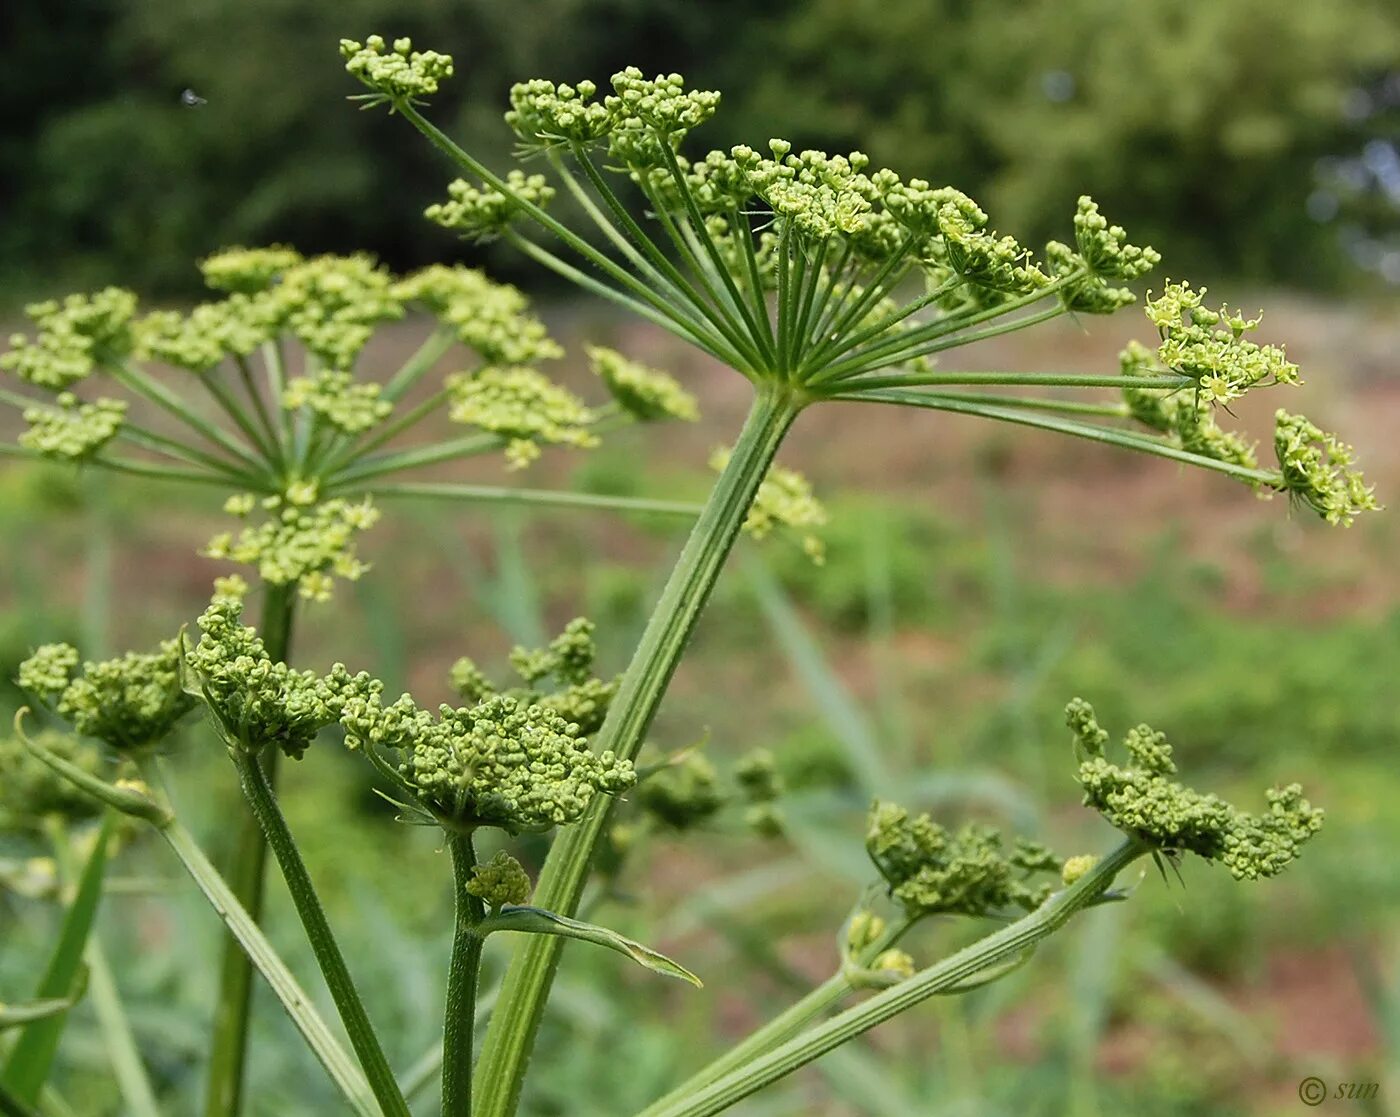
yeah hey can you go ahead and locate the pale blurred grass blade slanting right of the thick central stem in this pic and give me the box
[745,559,889,798]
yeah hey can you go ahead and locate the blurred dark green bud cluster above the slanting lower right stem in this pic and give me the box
[865,802,1060,918]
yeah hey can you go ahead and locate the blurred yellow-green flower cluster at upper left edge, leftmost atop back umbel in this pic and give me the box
[0,287,136,392]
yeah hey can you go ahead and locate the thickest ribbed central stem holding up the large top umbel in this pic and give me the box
[477,386,801,1117]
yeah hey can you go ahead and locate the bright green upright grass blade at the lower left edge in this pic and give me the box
[0,810,116,1106]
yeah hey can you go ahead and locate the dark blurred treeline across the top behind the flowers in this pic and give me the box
[0,0,1400,295]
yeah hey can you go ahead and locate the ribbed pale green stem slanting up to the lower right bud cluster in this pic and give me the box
[638,838,1148,1117]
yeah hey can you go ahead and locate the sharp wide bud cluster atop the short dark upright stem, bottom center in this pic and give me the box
[340,686,636,833]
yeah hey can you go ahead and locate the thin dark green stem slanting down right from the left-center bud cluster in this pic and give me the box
[231,749,409,1117]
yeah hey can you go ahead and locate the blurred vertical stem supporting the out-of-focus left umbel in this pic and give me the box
[204,585,297,1117]
